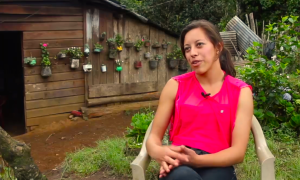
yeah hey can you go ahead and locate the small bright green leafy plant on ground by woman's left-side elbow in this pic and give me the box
[126,111,154,147]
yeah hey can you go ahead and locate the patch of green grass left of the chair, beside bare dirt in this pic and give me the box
[64,138,158,179]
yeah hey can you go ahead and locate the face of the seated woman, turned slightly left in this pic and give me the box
[184,28,219,74]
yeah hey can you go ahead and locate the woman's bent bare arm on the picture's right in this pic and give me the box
[192,88,253,167]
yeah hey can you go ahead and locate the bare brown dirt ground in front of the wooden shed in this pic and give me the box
[14,112,133,180]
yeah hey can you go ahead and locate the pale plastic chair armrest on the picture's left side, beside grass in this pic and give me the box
[130,121,153,180]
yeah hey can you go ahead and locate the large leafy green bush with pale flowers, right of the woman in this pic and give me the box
[239,16,300,132]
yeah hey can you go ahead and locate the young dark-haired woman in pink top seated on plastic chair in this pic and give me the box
[147,20,253,180]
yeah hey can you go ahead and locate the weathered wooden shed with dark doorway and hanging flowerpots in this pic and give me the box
[0,0,183,132]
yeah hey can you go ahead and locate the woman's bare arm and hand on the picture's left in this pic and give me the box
[146,79,188,165]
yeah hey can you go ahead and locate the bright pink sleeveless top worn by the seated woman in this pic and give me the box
[170,71,252,153]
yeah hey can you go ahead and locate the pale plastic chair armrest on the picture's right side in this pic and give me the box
[252,116,275,180]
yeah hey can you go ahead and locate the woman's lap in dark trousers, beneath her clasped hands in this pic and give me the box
[159,165,236,180]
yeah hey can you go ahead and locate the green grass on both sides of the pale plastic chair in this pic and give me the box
[65,134,300,180]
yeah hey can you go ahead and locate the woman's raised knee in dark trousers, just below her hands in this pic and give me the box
[160,166,202,180]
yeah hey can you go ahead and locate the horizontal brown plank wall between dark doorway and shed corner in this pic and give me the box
[0,5,85,126]
